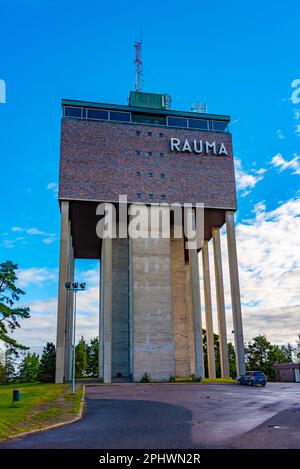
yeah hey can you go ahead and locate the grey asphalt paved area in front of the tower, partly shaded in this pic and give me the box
[0,383,300,449]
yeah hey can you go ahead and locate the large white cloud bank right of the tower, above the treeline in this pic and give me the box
[218,197,300,343]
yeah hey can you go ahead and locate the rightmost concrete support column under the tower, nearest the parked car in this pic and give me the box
[225,211,246,375]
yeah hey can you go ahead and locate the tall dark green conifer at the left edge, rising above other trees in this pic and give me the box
[0,261,30,351]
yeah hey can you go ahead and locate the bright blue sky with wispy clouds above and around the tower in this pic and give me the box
[0,0,300,347]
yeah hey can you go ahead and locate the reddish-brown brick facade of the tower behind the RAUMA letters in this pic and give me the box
[59,118,236,209]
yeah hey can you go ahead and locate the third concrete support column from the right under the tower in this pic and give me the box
[202,240,216,378]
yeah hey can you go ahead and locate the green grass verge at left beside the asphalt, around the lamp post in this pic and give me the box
[0,383,83,441]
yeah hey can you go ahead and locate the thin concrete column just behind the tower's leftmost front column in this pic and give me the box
[65,230,75,381]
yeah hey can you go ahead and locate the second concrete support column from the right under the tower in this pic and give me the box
[212,227,229,378]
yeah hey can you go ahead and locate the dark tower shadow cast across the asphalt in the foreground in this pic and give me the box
[0,399,195,449]
